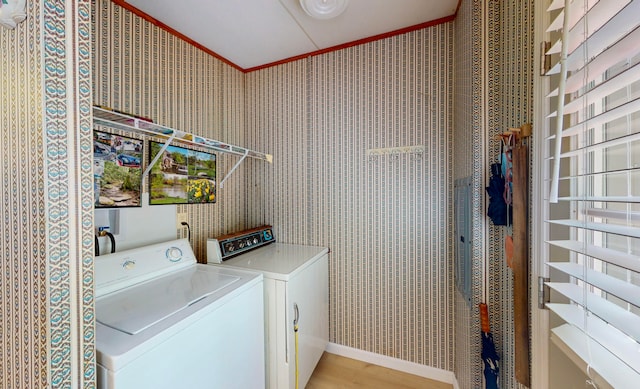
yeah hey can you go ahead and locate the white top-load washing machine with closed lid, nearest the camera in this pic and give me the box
[95,239,265,389]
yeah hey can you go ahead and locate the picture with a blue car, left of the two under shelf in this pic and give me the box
[93,130,142,208]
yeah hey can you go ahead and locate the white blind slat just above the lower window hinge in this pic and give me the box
[548,262,640,307]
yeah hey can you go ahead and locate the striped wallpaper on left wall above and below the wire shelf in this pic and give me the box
[93,0,250,261]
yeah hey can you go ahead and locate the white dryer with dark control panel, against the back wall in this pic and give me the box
[207,226,329,389]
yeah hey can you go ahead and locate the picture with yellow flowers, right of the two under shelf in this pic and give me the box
[149,142,216,205]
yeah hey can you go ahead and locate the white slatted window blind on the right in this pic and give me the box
[545,0,640,388]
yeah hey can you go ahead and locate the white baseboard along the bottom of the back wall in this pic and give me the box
[326,343,460,389]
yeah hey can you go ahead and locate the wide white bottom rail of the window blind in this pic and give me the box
[551,324,640,389]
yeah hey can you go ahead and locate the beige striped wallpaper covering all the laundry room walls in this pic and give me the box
[0,0,533,389]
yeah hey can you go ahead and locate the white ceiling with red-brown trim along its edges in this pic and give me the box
[119,0,459,71]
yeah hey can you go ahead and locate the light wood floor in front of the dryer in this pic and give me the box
[306,352,453,389]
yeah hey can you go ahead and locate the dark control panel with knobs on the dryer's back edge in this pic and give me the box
[207,226,276,263]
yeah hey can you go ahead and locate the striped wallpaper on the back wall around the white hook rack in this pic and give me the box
[247,23,453,370]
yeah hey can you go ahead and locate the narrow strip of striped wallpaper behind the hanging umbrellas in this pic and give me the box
[485,0,536,388]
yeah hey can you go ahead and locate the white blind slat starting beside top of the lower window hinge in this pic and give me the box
[545,282,640,342]
